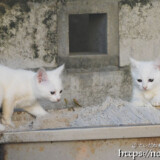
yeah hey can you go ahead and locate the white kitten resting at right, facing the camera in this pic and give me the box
[130,58,160,106]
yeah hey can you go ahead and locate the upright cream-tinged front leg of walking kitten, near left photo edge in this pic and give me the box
[2,99,14,127]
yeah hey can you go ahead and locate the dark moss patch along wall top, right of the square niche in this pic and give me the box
[120,0,152,8]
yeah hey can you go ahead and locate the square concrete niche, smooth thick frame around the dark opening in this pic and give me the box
[57,0,119,69]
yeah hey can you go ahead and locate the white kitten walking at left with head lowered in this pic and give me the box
[0,65,64,125]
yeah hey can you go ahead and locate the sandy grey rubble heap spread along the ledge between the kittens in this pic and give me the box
[2,97,160,132]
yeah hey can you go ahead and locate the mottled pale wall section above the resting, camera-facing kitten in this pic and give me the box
[119,0,160,66]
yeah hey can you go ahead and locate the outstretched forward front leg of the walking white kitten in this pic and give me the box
[23,102,48,117]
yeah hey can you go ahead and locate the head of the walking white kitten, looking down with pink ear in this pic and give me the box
[36,65,64,102]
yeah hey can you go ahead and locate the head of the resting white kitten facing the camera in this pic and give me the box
[130,58,160,91]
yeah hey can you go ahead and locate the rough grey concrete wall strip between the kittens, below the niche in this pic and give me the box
[42,66,132,109]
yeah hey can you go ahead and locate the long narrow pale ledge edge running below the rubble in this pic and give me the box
[0,125,160,144]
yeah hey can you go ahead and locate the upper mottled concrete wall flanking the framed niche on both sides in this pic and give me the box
[0,0,160,68]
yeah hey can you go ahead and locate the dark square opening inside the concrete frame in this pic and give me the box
[69,13,107,55]
